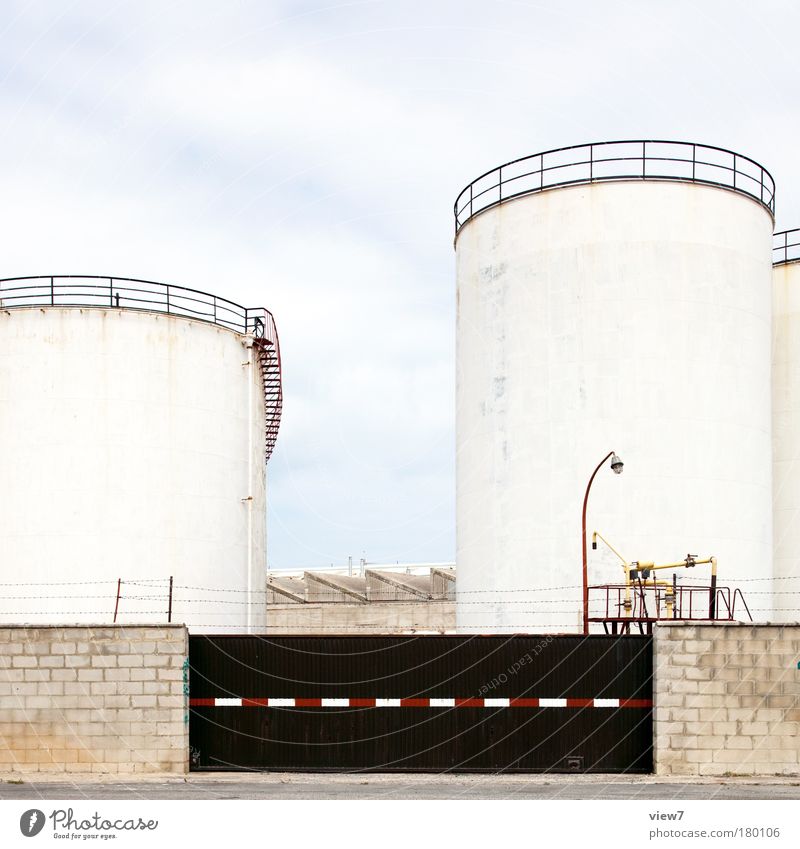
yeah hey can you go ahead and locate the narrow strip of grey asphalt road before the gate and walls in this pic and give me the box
[0,773,800,800]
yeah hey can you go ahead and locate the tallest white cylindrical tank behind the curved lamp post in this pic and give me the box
[456,142,774,632]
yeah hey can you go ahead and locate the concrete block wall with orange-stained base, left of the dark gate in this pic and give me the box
[0,625,189,774]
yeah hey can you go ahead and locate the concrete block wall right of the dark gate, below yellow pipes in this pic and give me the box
[653,623,800,776]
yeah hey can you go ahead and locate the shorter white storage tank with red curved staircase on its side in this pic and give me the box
[0,277,280,633]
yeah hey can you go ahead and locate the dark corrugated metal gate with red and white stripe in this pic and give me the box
[189,635,653,772]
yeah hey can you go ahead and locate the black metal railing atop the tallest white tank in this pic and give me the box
[453,139,775,235]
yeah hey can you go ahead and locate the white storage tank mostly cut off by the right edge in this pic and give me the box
[772,230,800,622]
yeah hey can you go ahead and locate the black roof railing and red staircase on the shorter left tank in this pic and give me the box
[0,274,283,460]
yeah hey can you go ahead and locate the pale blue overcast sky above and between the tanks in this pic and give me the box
[0,0,800,568]
